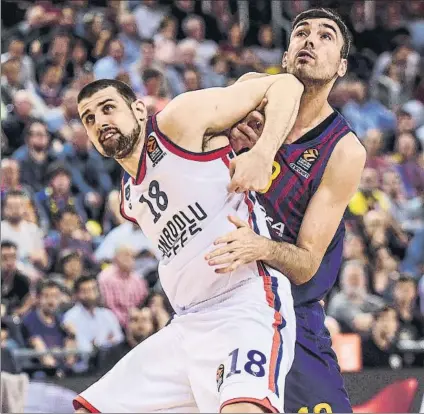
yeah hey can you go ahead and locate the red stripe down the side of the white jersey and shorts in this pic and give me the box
[244,192,283,393]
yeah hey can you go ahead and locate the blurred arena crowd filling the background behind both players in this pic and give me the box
[1,0,424,412]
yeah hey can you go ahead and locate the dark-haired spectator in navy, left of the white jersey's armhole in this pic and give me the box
[35,161,87,229]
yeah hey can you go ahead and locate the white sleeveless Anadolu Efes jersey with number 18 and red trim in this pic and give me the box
[121,116,278,313]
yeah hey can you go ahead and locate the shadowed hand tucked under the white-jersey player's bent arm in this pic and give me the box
[230,98,268,152]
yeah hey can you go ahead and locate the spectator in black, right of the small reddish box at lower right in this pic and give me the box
[362,306,401,368]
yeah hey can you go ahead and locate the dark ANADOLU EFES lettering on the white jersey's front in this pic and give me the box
[158,202,208,259]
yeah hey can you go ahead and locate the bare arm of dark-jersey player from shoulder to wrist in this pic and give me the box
[265,133,366,285]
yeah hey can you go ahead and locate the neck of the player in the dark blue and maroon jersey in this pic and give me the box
[286,83,333,143]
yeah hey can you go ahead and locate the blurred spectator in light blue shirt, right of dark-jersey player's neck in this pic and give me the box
[342,80,395,139]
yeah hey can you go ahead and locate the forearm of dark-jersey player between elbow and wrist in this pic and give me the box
[263,239,319,285]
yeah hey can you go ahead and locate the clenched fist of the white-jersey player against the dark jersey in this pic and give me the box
[228,148,274,193]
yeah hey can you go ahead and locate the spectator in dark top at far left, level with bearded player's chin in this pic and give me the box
[12,121,56,192]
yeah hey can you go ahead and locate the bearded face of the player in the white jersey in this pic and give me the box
[78,87,146,159]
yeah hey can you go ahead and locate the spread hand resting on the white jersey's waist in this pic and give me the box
[205,216,269,274]
